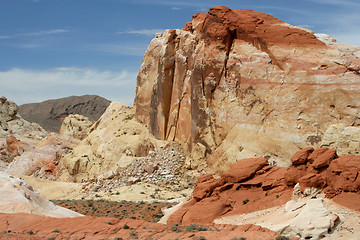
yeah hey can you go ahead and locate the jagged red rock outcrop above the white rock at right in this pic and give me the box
[167,148,360,225]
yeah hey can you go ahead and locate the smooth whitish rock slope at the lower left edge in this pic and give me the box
[0,172,82,218]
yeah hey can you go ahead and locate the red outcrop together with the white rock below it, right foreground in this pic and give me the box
[164,148,360,239]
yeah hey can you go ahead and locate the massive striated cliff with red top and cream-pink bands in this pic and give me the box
[134,6,360,173]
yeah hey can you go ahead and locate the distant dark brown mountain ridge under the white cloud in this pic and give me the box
[19,95,111,132]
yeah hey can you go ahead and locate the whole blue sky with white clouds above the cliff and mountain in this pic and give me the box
[0,0,360,104]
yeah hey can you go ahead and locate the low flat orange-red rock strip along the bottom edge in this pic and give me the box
[0,213,286,240]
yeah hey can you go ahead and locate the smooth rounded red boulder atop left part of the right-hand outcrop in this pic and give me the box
[222,158,268,183]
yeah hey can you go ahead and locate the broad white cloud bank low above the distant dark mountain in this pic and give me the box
[0,67,137,105]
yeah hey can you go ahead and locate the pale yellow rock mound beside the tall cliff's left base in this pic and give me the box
[60,102,164,181]
